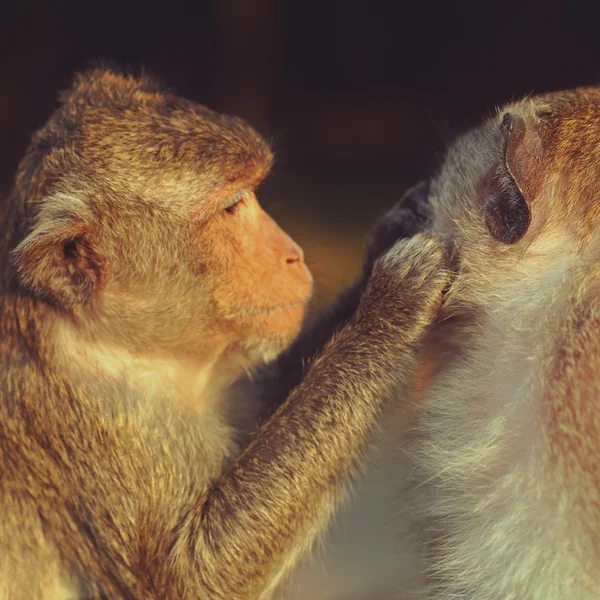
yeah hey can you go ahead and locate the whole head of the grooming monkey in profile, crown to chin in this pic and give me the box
[8,70,312,368]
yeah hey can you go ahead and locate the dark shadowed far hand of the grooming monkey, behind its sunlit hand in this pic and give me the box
[364,181,431,277]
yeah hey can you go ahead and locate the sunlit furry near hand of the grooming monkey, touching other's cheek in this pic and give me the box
[357,234,452,341]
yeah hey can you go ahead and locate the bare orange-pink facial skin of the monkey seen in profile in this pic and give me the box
[196,191,312,356]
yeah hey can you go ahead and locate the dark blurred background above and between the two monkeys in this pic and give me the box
[0,0,600,302]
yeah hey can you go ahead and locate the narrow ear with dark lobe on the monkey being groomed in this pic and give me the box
[484,113,534,244]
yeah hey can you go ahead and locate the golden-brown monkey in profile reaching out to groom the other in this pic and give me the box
[0,70,448,600]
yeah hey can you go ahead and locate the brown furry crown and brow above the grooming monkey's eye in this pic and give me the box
[43,70,273,197]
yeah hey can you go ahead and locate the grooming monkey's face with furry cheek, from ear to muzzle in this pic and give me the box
[86,191,312,360]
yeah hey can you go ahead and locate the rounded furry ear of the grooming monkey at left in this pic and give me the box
[13,224,102,309]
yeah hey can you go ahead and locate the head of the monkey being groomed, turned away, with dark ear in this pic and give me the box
[414,88,600,306]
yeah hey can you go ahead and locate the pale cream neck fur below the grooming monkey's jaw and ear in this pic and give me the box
[0,290,255,413]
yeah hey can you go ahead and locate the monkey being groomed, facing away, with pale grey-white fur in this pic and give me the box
[392,88,600,600]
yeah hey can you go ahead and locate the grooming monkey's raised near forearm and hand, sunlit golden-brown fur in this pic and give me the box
[166,238,448,600]
